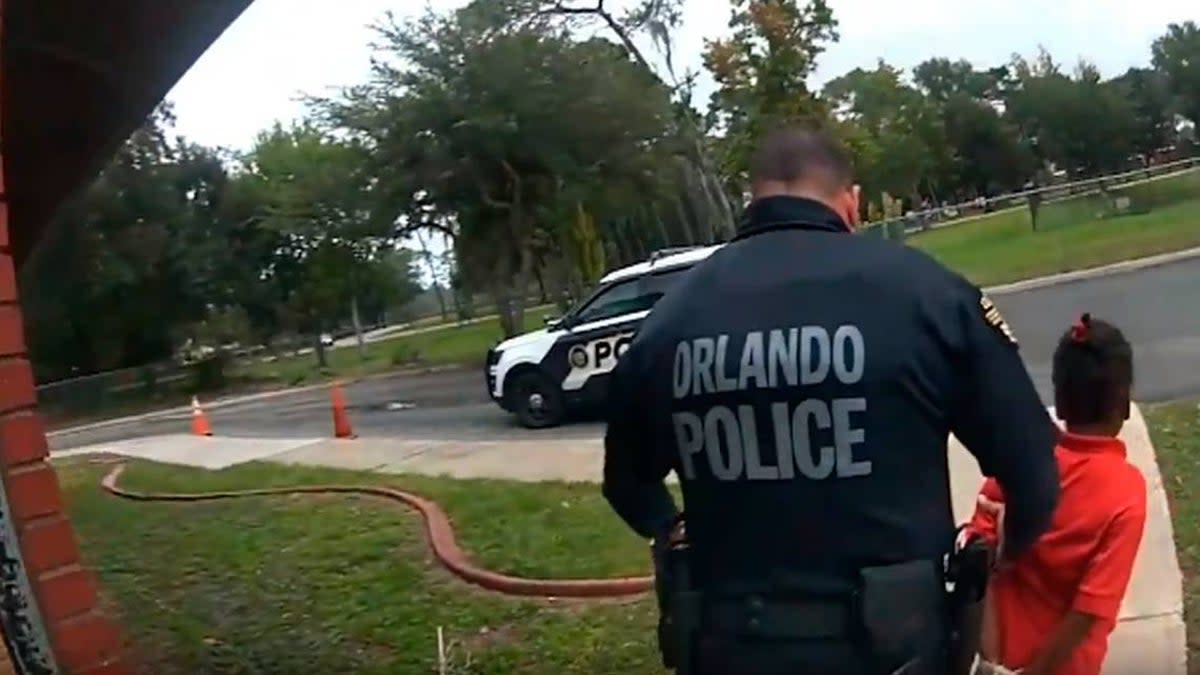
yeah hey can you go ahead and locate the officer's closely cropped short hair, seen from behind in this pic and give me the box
[750,126,853,190]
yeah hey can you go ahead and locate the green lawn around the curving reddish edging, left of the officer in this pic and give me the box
[59,454,662,675]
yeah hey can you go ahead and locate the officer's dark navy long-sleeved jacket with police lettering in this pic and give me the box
[604,197,1058,583]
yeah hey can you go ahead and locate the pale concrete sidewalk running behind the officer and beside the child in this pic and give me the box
[53,401,1187,675]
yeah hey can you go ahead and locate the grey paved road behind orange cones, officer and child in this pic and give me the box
[50,259,1200,449]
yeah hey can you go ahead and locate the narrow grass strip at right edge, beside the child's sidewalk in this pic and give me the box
[1145,400,1200,674]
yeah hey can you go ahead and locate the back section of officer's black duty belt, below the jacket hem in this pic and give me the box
[702,596,858,640]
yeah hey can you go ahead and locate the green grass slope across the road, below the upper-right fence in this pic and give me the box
[908,171,1200,286]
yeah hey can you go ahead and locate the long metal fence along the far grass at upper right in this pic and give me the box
[864,157,1200,239]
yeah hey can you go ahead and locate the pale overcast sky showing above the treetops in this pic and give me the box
[168,0,1200,149]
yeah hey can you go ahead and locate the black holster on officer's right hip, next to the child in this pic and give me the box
[946,530,995,675]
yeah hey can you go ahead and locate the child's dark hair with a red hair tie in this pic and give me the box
[1052,313,1133,424]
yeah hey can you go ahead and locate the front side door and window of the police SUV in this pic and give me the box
[544,270,682,402]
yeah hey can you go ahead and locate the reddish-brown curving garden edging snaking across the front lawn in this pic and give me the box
[101,464,654,598]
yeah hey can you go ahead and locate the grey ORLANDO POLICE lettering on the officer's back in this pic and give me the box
[672,325,871,480]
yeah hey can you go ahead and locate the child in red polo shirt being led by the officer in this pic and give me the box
[967,313,1146,675]
